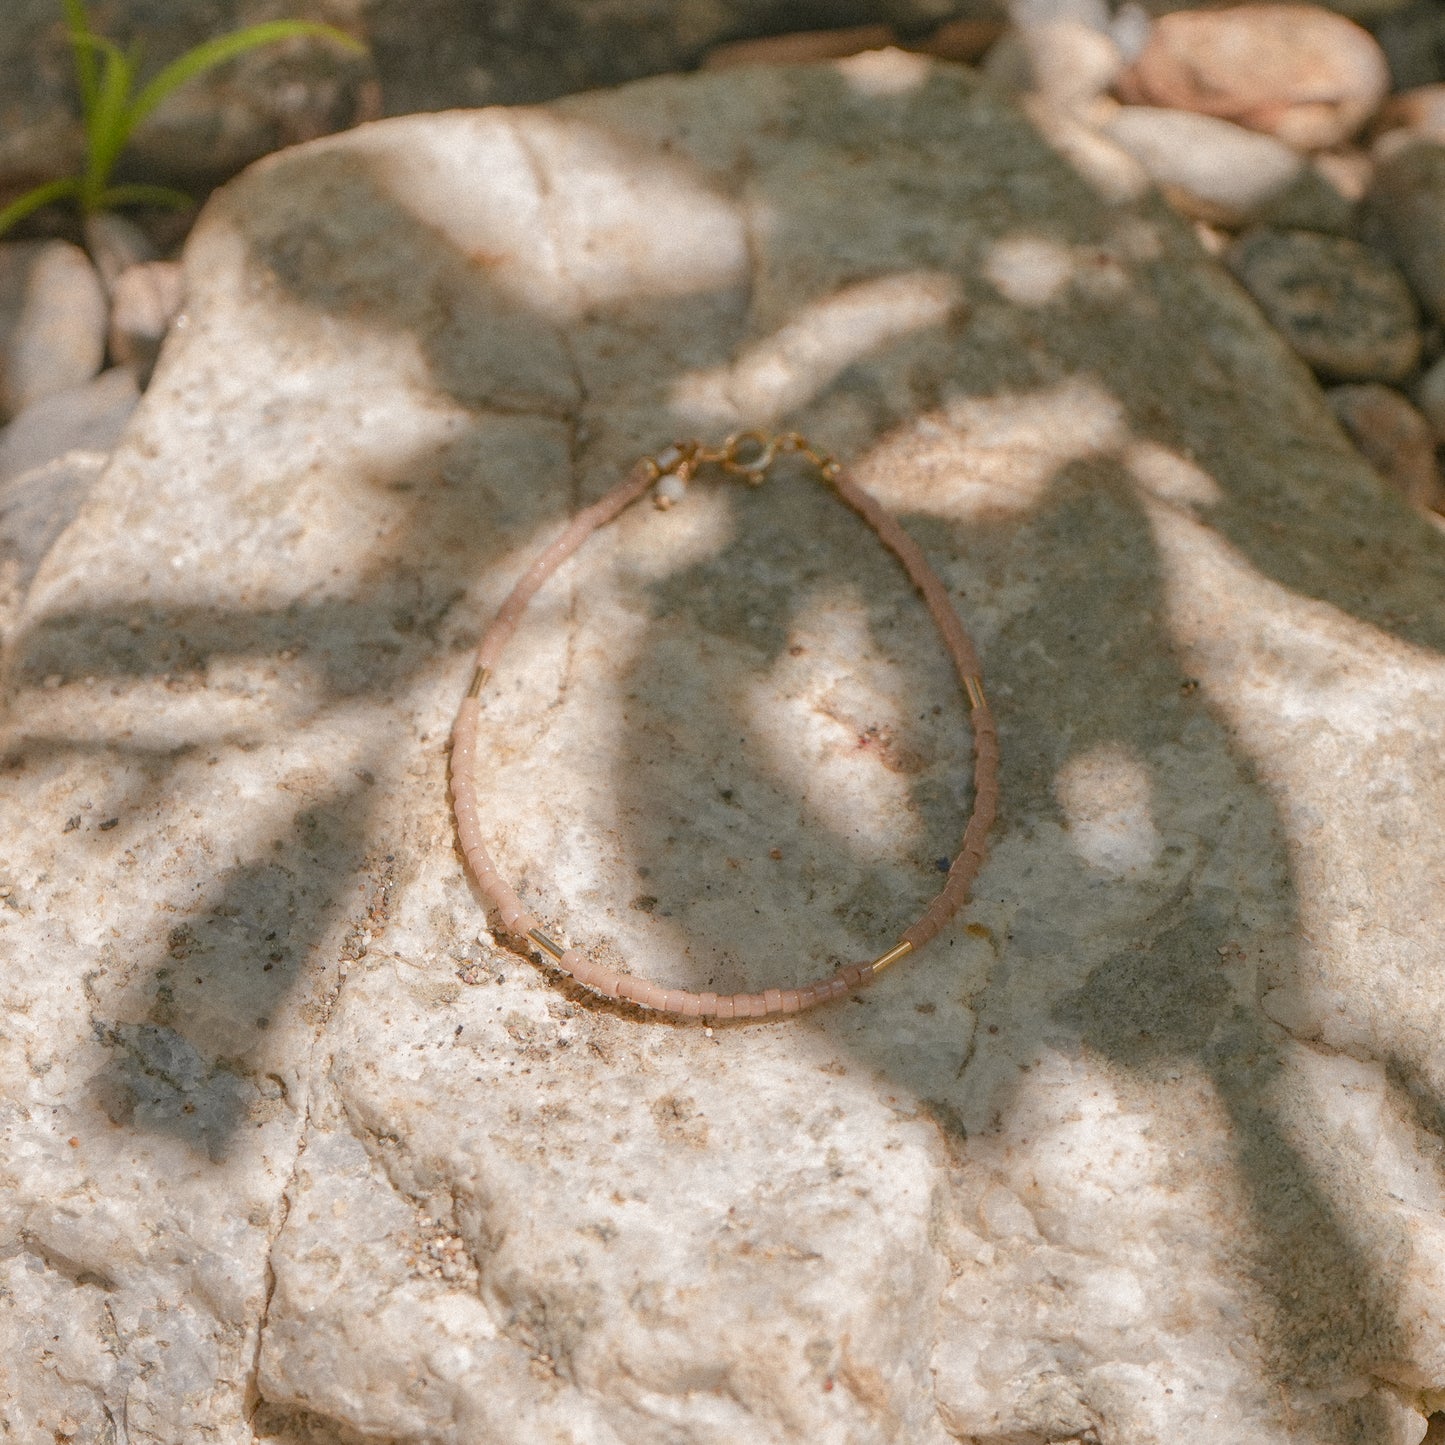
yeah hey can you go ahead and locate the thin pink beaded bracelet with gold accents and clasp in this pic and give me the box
[451,432,998,1019]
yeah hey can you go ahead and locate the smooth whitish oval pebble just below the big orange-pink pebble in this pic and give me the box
[1101,105,1353,231]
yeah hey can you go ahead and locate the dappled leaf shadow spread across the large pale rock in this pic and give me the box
[2,59,1445,1441]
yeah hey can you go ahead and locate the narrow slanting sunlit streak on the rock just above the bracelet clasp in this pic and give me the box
[672,272,959,425]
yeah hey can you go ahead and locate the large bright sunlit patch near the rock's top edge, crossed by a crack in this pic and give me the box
[367,110,747,321]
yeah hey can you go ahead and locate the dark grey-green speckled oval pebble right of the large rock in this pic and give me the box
[1228,231,1422,381]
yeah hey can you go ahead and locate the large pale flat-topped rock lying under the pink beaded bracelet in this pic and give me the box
[0,55,1445,1445]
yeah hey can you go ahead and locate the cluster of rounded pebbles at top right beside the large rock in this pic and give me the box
[1092,4,1445,514]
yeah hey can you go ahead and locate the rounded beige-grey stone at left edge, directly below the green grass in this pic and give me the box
[0,241,105,419]
